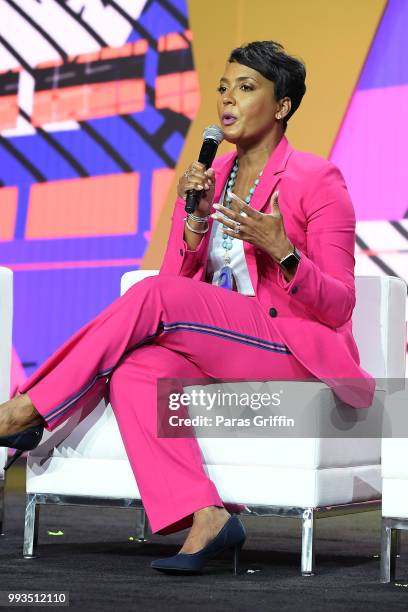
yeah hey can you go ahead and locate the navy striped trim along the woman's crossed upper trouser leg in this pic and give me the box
[43,321,291,423]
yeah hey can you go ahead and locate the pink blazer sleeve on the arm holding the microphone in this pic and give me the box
[159,198,206,280]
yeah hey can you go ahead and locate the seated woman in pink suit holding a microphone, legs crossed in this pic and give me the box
[0,41,375,572]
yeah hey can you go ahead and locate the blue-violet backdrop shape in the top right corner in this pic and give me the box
[357,0,408,90]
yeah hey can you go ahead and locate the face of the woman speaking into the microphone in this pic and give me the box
[217,62,286,145]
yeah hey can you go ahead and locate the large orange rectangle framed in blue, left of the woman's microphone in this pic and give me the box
[25,172,140,240]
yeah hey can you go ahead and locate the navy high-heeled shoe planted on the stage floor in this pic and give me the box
[151,514,246,576]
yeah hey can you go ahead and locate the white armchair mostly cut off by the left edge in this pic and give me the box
[0,268,13,534]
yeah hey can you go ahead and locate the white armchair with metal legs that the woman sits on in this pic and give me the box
[24,270,406,575]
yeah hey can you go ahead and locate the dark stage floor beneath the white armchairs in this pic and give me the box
[0,462,408,612]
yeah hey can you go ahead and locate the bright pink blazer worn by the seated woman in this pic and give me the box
[159,137,375,408]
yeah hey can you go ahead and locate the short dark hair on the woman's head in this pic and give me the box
[228,40,306,129]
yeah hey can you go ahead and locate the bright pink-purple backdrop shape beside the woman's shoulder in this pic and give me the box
[330,85,408,221]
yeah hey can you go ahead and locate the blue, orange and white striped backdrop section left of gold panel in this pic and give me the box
[0,0,199,390]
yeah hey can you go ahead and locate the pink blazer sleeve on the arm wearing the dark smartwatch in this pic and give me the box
[277,162,356,328]
